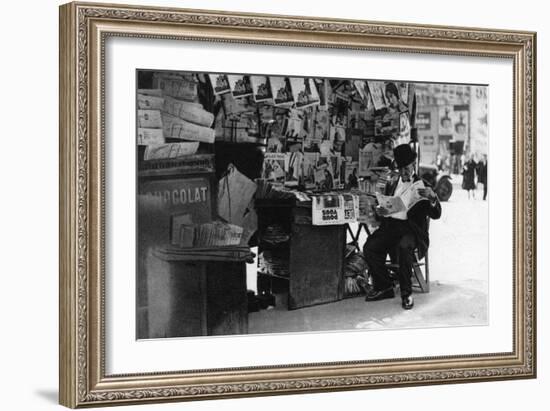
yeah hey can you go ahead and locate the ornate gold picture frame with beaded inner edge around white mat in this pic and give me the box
[59,3,536,408]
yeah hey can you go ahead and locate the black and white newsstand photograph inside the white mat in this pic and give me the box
[136,69,491,339]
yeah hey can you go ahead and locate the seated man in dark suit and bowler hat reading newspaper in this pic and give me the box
[363,144,441,310]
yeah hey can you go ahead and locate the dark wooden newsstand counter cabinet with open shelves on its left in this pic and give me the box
[256,199,346,310]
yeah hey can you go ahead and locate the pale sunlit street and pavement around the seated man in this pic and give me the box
[249,176,488,333]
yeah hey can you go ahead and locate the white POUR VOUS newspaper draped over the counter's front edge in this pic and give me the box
[311,194,359,225]
